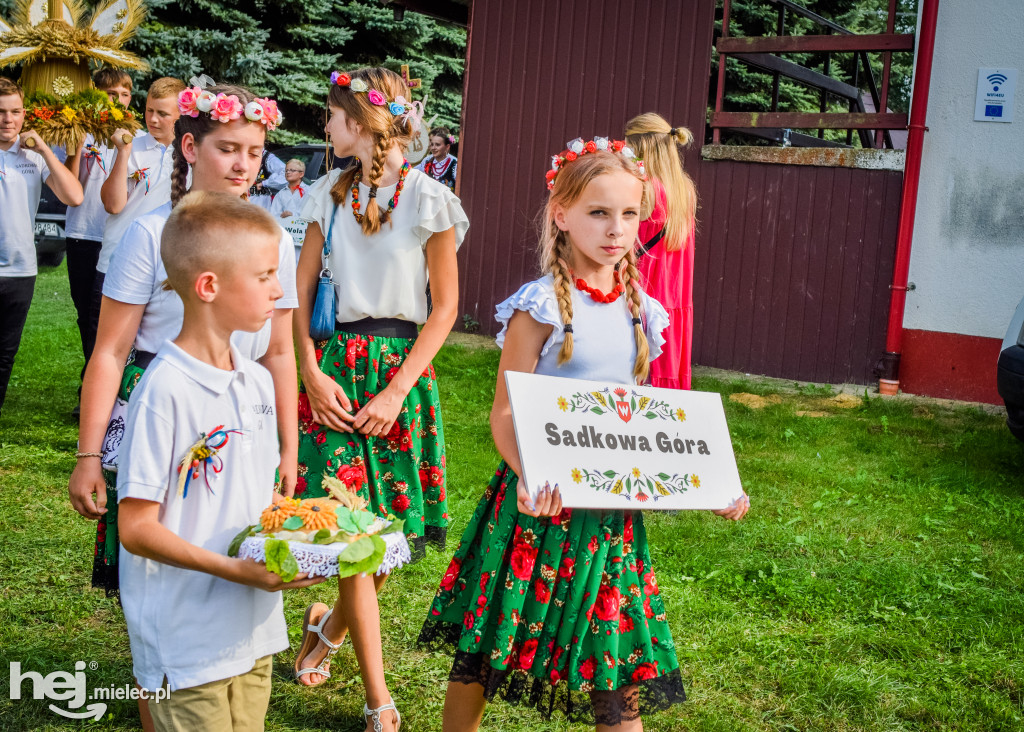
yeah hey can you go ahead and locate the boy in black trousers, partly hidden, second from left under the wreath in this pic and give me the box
[65,68,132,418]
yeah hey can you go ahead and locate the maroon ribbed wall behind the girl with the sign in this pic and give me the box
[459,0,902,383]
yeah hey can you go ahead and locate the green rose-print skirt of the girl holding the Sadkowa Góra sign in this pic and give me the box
[420,462,686,725]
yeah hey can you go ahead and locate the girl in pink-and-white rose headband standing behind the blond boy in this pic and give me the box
[69,85,298,594]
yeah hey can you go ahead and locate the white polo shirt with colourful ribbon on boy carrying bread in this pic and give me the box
[118,342,288,691]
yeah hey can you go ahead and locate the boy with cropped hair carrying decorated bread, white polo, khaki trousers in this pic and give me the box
[118,191,322,732]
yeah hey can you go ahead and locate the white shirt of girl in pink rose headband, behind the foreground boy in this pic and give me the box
[103,202,299,360]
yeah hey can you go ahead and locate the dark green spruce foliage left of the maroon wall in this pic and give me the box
[0,0,466,143]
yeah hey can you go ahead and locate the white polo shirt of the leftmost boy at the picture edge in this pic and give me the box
[0,138,50,277]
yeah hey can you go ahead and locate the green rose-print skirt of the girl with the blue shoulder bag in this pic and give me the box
[295,331,449,558]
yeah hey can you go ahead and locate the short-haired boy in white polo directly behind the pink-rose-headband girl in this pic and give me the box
[92,77,185,311]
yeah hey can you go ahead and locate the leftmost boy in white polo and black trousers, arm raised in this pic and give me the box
[0,77,82,417]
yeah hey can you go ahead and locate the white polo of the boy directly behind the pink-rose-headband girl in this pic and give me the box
[96,133,174,272]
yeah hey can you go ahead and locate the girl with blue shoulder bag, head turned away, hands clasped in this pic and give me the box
[295,69,469,732]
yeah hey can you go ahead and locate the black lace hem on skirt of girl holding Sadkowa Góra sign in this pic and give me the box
[418,619,686,726]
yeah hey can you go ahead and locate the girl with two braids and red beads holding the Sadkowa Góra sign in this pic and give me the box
[420,137,746,732]
